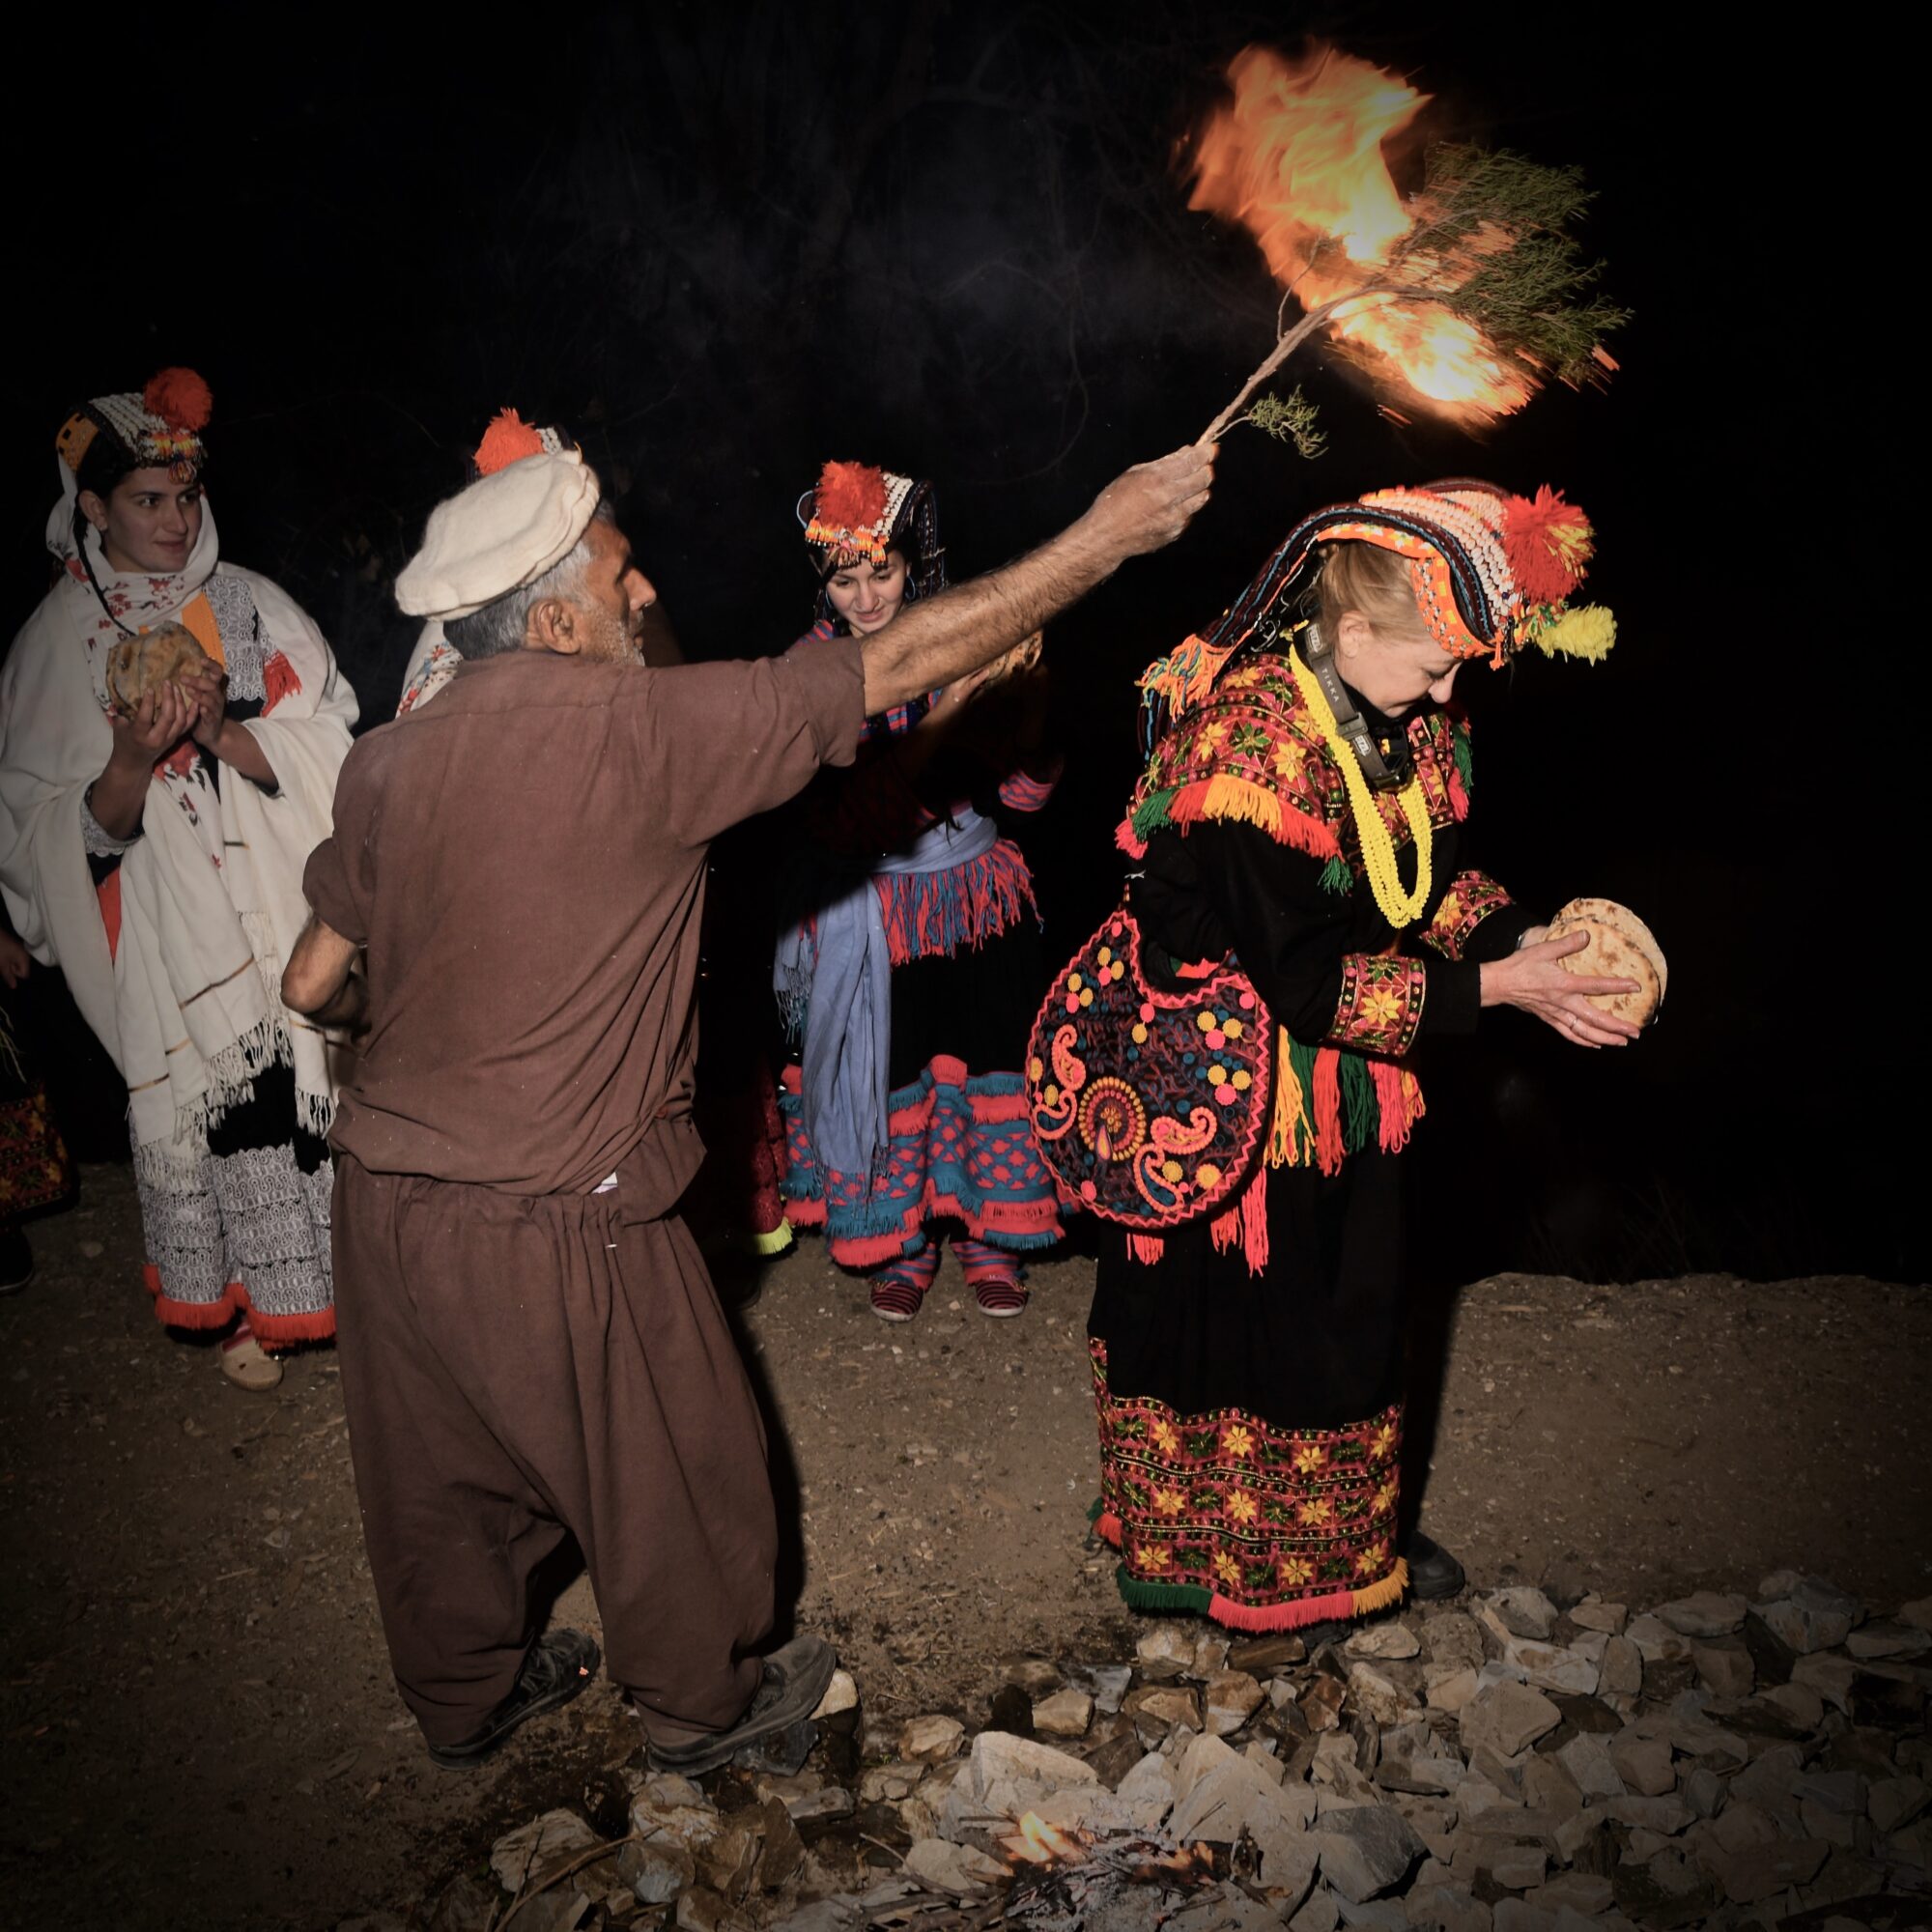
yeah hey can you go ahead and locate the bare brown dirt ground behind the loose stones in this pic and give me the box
[0,1167,1932,1932]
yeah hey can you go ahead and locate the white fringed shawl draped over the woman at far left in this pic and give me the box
[0,498,355,1186]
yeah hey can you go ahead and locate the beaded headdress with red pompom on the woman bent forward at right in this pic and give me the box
[1142,477,1617,744]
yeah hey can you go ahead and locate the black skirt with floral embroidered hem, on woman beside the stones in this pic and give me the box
[1088,1150,1406,1631]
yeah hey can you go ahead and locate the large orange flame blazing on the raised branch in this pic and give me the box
[1188,46,1532,415]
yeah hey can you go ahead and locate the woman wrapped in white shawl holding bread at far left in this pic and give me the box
[0,369,355,1387]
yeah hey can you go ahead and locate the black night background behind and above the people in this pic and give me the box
[0,14,1901,1279]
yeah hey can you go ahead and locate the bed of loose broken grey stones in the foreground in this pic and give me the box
[435,1571,1932,1932]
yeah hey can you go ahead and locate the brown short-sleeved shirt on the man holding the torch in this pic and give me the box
[303,639,864,1215]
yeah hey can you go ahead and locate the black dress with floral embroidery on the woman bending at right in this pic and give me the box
[1088,657,1530,1629]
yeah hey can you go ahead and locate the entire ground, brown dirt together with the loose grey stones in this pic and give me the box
[0,1167,1932,1932]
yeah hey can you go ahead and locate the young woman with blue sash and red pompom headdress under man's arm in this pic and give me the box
[777,464,1061,1321]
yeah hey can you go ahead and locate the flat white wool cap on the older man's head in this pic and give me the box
[396,450,601,624]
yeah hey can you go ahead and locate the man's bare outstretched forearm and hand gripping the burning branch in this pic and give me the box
[862,444,1215,715]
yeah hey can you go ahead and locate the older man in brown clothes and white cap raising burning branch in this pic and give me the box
[284,431,1211,1772]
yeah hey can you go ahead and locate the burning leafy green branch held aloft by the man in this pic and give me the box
[1190,48,1627,456]
